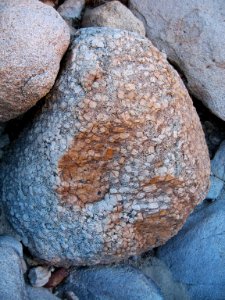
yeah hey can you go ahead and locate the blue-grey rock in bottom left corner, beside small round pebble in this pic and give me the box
[0,237,28,300]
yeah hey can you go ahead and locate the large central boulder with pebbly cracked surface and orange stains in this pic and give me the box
[2,28,210,265]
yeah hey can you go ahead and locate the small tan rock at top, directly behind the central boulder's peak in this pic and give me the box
[82,1,145,36]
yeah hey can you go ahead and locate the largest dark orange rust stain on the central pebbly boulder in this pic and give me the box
[57,122,134,206]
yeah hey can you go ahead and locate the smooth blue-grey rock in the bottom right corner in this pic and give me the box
[158,195,225,300]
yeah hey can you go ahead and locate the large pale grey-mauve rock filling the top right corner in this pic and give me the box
[130,0,225,120]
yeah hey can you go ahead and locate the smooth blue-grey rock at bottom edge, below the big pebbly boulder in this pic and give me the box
[59,266,163,300]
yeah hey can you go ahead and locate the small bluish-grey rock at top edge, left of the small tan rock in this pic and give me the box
[57,0,85,28]
